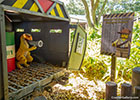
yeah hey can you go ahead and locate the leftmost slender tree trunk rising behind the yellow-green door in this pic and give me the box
[82,0,94,28]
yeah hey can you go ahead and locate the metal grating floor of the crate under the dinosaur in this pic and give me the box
[8,63,65,99]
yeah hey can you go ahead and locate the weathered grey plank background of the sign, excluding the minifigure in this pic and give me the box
[101,13,134,58]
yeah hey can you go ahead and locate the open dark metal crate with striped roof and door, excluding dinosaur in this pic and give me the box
[0,0,87,100]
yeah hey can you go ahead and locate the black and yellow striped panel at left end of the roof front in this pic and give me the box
[2,0,40,12]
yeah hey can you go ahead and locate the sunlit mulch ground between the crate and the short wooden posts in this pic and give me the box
[47,72,105,100]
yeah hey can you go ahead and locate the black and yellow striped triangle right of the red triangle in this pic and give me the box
[49,3,68,18]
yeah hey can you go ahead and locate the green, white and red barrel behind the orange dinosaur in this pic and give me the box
[6,32,15,72]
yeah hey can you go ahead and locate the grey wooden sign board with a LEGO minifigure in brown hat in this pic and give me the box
[101,12,134,58]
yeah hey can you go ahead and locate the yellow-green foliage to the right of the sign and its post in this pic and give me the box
[117,23,140,81]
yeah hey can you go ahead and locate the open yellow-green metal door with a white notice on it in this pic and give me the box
[68,25,87,70]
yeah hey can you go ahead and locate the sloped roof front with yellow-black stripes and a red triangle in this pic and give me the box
[0,0,69,21]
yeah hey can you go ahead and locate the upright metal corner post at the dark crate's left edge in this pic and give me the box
[0,7,8,100]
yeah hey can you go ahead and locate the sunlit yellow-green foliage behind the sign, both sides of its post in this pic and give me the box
[82,23,140,82]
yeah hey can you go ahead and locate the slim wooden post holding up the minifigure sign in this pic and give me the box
[111,55,116,82]
